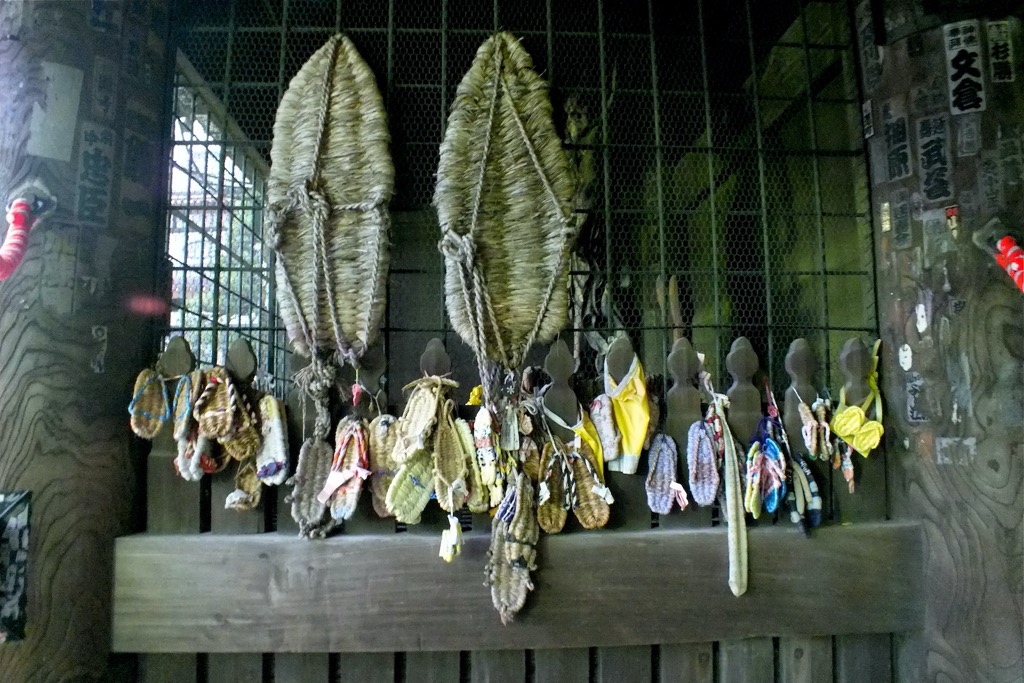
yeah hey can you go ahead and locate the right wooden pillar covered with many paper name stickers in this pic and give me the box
[857,0,1024,681]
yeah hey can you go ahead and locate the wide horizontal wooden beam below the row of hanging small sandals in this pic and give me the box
[114,522,924,652]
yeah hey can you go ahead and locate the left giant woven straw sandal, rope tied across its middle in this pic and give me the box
[265,34,394,362]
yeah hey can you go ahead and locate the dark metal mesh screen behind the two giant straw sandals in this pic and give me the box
[172,0,877,401]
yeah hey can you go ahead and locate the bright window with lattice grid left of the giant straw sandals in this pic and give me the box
[167,53,286,395]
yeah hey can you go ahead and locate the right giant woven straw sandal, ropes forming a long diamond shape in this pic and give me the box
[434,33,575,398]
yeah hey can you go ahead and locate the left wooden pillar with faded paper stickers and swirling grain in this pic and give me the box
[0,0,169,681]
